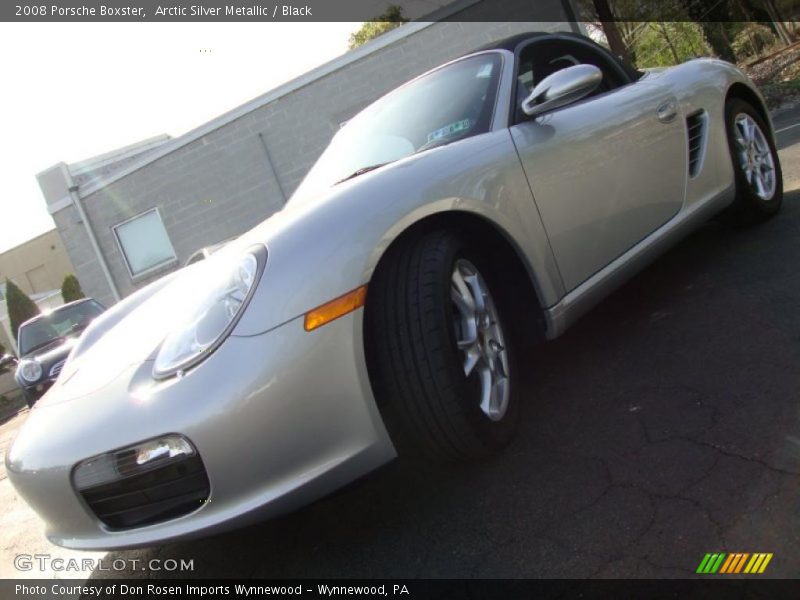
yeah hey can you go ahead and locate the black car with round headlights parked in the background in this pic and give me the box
[14,298,105,406]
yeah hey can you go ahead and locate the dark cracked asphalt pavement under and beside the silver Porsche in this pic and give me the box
[0,105,800,578]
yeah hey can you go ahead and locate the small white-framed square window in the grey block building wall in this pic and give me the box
[114,208,177,278]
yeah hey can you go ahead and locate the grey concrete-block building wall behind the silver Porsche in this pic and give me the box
[54,17,571,304]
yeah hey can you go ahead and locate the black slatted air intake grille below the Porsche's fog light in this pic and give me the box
[79,446,210,529]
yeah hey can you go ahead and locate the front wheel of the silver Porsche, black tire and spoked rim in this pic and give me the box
[365,231,519,459]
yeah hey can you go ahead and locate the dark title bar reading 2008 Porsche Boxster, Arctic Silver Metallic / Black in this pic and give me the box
[0,0,800,22]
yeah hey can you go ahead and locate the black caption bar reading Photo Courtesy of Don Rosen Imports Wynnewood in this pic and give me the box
[0,576,800,600]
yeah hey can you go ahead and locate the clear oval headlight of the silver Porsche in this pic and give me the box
[153,246,266,379]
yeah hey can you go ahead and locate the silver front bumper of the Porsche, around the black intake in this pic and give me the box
[6,310,395,549]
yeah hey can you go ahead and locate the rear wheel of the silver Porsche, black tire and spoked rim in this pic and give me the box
[725,98,783,225]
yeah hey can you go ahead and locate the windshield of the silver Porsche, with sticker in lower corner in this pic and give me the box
[291,53,502,202]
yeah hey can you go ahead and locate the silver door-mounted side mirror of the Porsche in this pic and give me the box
[521,65,603,117]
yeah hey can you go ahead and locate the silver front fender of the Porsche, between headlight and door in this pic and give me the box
[234,129,564,335]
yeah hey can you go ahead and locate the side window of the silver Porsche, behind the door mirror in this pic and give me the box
[516,40,628,122]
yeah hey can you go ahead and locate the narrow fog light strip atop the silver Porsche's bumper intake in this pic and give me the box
[73,434,195,490]
